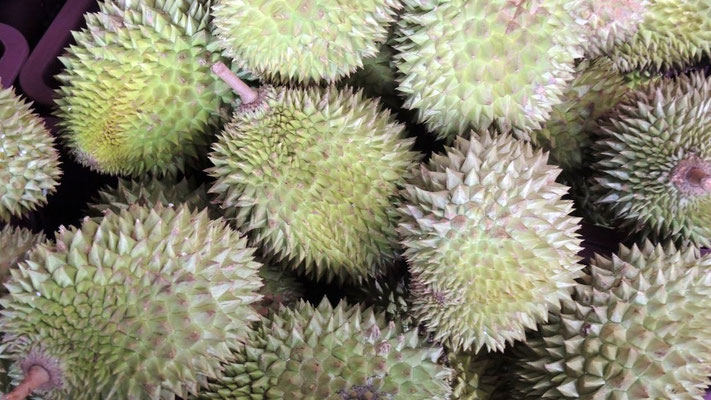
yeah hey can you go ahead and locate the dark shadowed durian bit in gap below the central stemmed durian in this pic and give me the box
[254,263,306,315]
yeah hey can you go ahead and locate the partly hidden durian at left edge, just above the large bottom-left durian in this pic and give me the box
[0,225,45,293]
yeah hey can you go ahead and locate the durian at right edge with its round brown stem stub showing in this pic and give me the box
[593,73,711,246]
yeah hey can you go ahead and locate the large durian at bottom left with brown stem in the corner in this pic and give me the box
[0,204,262,400]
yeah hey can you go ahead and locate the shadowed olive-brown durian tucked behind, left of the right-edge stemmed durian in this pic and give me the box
[531,58,629,170]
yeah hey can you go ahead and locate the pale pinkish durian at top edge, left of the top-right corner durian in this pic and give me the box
[571,0,649,58]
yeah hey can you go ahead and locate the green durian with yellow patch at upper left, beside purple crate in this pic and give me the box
[57,0,233,176]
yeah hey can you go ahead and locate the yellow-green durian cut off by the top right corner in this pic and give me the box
[608,0,711,72]
